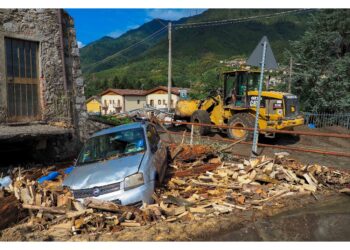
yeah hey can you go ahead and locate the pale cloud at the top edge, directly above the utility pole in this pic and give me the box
[147,9,205,20]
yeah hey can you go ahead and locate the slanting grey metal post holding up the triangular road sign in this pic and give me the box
[251,40,267,158]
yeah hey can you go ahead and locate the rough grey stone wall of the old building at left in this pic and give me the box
[0,9,88,143]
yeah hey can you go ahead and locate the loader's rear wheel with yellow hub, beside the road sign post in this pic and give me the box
[227,113,255,141]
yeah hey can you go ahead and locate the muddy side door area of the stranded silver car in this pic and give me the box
[147,124,168,183]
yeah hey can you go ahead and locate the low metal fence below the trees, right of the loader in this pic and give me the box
[302,112,350,129]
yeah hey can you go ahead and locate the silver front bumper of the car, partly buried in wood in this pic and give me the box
[78,181,155,205]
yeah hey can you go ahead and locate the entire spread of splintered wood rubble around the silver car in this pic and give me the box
[0,144,350,240]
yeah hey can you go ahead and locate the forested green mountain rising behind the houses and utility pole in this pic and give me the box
[81,9,312,95]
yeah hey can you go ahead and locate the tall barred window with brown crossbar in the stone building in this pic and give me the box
[5,38,40,122]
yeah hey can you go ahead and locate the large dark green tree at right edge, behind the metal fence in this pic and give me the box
[292,9,350,112]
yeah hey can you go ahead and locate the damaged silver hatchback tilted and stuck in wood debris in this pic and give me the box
[63,122,168,205]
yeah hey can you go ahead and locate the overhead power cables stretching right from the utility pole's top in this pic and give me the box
[174,9,312,29]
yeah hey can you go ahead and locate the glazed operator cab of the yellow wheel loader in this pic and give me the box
[223,70,260,108]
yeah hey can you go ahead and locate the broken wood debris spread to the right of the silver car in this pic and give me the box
[152,145,350,221]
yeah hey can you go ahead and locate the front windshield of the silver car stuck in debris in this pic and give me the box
[77,128,146,165]
